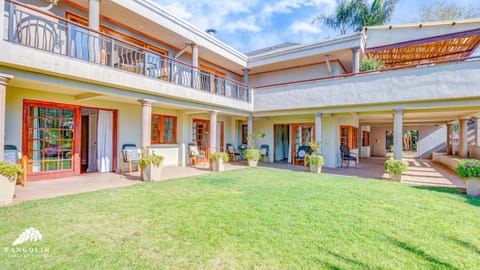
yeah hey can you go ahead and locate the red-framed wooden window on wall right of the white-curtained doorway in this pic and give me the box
[152,114,177,144]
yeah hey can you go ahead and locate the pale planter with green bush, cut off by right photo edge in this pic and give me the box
[456,159,480,197]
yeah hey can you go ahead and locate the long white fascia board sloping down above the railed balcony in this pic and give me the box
[111,0,248,67]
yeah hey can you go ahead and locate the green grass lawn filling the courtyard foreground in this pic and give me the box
[0,168,480,269]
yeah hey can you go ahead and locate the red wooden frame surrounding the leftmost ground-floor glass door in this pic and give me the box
[22,99,118,181]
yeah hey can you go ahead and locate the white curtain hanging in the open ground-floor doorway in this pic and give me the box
[97,110,113,172]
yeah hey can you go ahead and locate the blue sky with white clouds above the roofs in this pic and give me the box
[155,0,480,52]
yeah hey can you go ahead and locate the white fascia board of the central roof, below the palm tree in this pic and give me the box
[248,32,365,68]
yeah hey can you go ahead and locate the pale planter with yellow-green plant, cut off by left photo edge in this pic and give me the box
[0,162,24,205]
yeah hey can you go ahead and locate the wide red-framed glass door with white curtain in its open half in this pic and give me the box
[22,100,117,180]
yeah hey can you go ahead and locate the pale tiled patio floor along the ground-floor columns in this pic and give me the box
[13,158,465,204]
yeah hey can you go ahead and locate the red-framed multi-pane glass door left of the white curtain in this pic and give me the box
[22,100,117,181]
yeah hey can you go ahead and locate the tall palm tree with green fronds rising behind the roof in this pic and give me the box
[313,0,398,35]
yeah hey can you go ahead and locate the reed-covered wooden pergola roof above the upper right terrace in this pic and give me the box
[365,28,480,68]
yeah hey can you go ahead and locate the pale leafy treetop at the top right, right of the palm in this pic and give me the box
[419,0,480,22]
